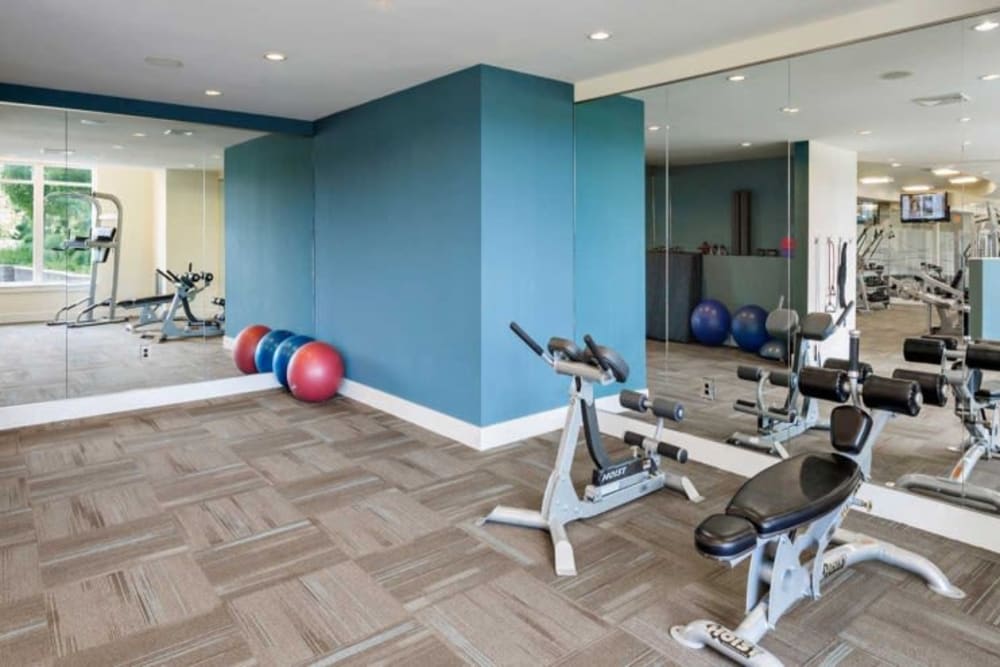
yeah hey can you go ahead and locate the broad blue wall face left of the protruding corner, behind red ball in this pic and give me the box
[314,68,482,424]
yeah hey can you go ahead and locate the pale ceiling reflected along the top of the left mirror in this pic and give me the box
[0,104,260,169]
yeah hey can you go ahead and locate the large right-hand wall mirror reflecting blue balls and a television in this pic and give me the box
[604,13,1000,512]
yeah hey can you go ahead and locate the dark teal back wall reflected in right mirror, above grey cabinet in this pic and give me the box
[669,157,788,250]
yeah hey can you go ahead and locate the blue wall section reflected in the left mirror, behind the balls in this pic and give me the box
[224,135,314,336]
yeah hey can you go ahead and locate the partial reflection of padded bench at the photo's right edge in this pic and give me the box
[893,337,1000,512]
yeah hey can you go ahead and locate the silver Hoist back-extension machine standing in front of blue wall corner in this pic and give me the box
[481,322,703,576]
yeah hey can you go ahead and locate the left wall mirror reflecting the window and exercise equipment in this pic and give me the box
[0,104,259,406]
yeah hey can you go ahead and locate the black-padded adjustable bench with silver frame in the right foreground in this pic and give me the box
[670,331,965,667]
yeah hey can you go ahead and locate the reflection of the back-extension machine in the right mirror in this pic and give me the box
[726,243,871,459]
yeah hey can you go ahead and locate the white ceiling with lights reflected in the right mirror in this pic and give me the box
[634,13,1000,185]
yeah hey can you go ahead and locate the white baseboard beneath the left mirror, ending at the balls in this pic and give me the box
[0,373,281,431]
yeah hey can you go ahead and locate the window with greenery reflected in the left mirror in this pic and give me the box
[0,163,93,283]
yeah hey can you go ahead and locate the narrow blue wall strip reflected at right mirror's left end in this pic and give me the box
[573,97,646,394]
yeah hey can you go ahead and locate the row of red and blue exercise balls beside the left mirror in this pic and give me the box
[233,324,344,402]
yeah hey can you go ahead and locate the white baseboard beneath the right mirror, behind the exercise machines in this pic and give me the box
[601,415,1000,552]
